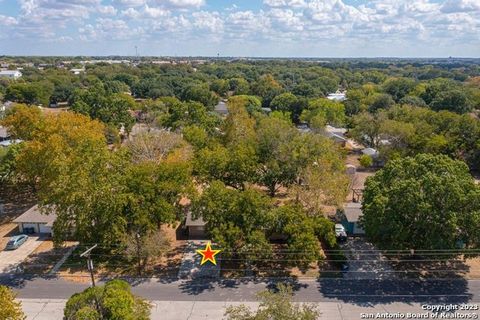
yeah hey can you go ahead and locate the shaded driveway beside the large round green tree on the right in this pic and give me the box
[341,238,397,280]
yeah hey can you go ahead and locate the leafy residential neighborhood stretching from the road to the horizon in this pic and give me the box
[0,57,480,319]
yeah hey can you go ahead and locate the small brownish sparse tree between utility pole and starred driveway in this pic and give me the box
[125,230,170,275]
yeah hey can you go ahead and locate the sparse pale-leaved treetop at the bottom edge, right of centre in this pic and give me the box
[225,284,319,320]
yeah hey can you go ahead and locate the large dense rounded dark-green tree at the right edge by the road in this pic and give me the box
[362,154,480,250]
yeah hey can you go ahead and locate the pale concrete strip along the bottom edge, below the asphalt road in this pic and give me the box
[21,299,480,320]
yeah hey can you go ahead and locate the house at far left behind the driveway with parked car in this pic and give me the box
[13,205,57,236]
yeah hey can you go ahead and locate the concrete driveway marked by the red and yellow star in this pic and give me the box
[178,240,220,279]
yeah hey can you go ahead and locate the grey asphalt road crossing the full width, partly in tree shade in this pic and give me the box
[0,275,480,305]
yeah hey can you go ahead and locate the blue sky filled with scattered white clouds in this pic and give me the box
[0,0,480,58]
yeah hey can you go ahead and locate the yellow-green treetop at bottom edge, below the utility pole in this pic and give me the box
[64,280,151,320]
